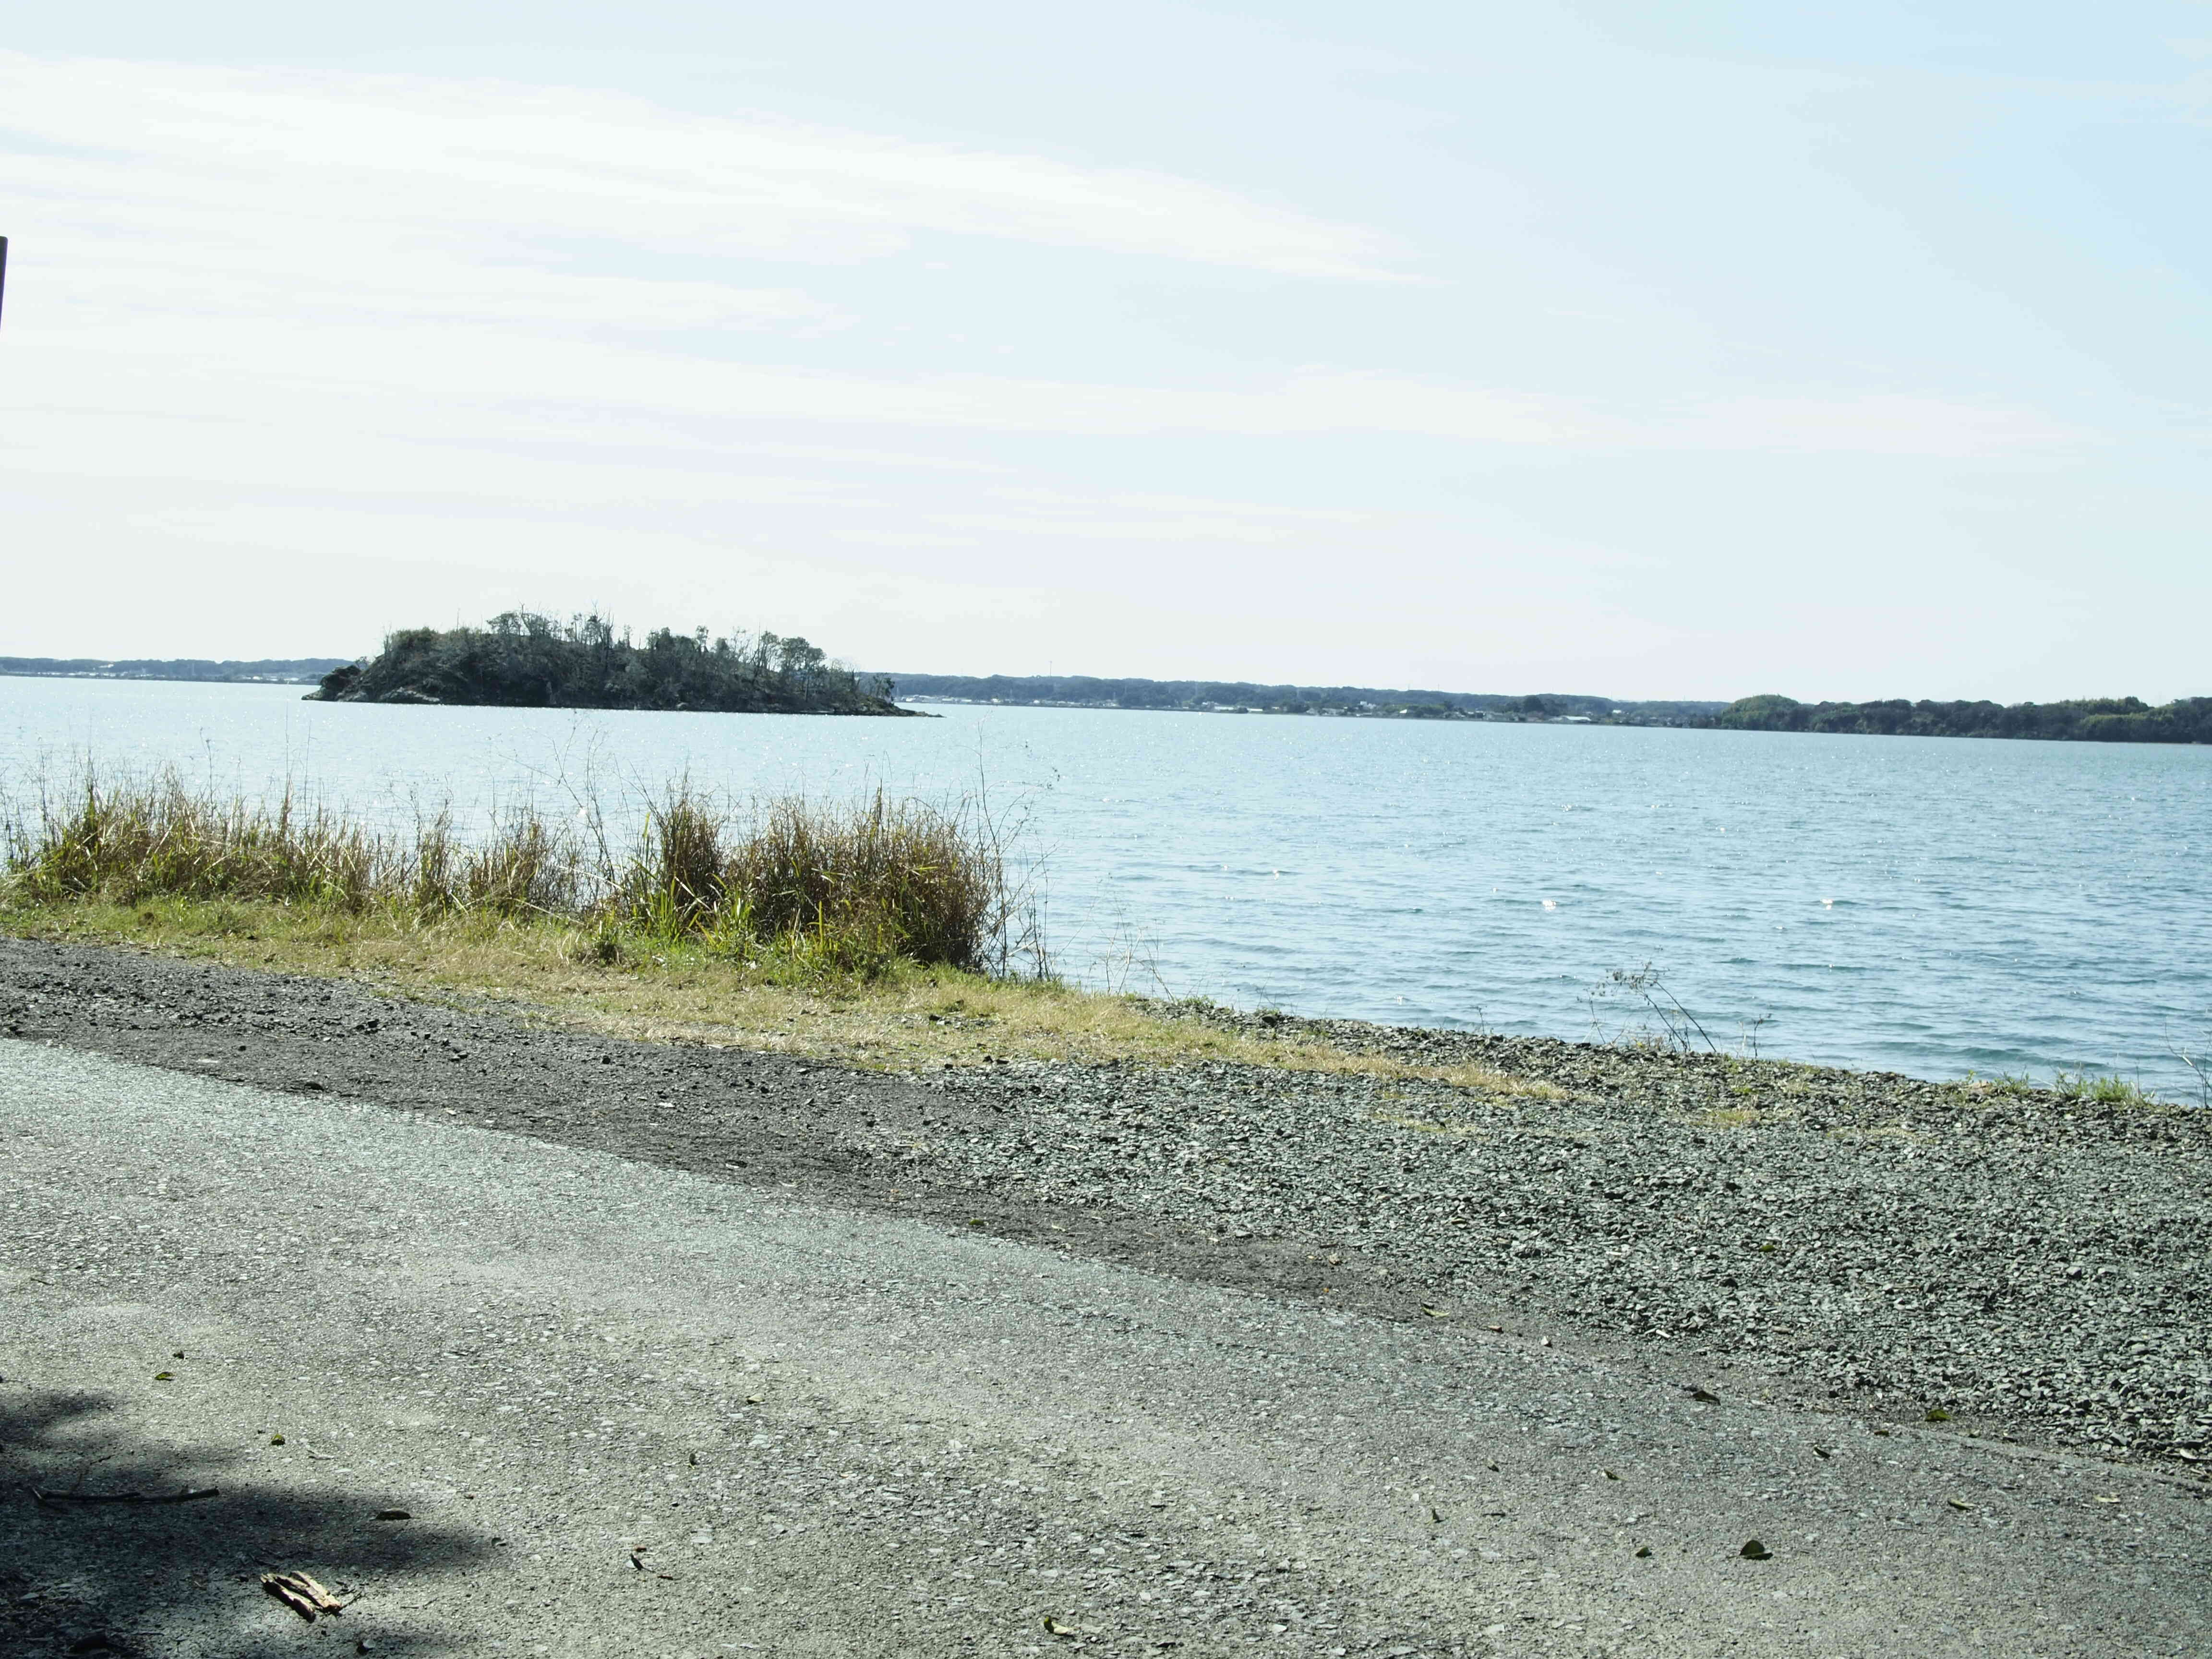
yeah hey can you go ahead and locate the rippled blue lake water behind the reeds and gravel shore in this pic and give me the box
[0,679,2212,1099]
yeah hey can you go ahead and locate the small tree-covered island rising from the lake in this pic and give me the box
[308,611,916,714]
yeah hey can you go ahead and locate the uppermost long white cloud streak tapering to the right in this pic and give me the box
[0,53,1402,292]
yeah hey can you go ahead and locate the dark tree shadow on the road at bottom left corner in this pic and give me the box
[0,1387,495,1659]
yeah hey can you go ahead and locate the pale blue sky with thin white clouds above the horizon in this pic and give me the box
[0,0,2212,701]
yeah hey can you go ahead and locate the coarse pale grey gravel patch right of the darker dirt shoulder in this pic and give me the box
[934,1011,2212,1464]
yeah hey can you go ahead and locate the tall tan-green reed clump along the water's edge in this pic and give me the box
[0,774,1044,975]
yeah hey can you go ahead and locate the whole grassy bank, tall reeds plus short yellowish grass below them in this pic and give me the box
[0,783,1560,1097]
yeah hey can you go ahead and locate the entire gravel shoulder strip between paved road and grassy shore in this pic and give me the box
[0,940,2212,1480]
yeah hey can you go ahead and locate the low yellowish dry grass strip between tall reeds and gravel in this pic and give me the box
[0,894,1562,1099]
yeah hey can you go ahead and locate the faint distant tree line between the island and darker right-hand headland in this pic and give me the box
[883,674,1723,725]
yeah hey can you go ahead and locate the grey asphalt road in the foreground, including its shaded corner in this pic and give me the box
[0,1042,2212,1659]
